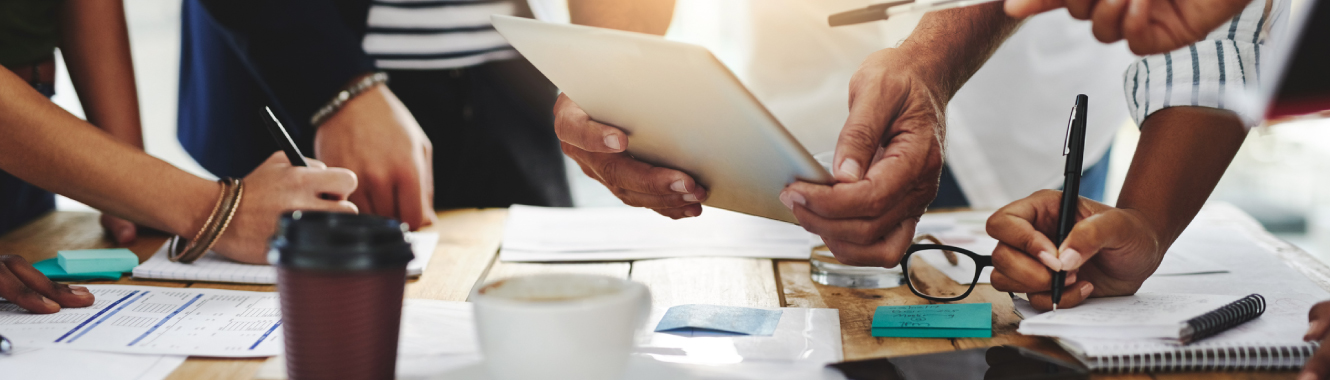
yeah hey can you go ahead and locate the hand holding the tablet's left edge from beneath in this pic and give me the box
[555,94,706,219]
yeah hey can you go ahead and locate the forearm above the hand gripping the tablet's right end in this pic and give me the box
[898,3,1021,104]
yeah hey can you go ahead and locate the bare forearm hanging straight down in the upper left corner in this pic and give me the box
[60,0,144,149]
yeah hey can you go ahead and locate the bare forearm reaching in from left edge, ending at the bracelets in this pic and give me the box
[0,69,211,235]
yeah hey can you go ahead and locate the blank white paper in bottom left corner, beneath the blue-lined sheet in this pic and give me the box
[0,347,185,380]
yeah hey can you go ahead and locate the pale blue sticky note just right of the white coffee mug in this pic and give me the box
[656,304,781,336]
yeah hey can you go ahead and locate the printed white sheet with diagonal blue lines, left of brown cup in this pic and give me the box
[0,284,282,357]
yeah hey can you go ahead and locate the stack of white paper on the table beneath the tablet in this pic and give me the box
[499,206,811,262]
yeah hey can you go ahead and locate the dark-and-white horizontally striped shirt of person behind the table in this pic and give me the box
[362,0,517,69]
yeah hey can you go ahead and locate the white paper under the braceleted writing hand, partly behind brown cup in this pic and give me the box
[133,233,439,284]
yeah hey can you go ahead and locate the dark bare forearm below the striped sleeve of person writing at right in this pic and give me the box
[1117,106,1246,254]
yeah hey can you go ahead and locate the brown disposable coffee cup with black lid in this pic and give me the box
[267,211,414,380]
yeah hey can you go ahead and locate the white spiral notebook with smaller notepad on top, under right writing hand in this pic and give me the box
[1017,294,1318,373]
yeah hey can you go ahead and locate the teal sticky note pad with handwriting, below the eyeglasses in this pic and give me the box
[872,303,994,337]
